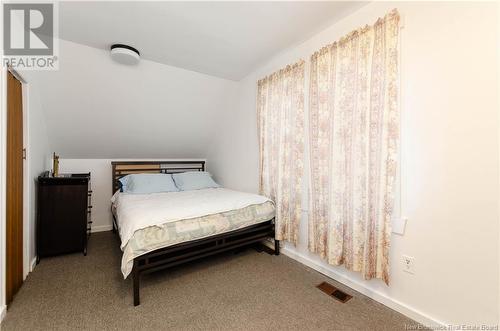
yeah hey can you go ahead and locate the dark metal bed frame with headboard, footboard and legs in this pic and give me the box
[111,161,279,306]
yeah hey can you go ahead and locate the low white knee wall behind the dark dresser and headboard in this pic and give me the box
[59,158,209,232]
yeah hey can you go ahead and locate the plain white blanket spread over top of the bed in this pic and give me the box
[111,188,270,250]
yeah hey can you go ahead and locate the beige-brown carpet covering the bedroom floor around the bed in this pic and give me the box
[1,232,415,330]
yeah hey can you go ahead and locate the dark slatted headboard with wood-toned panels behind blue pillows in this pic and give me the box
[111,161,205,194]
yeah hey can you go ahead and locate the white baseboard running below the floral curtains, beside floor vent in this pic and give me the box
[281,247,448,328]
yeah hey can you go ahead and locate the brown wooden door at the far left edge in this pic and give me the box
[6,72,23,304]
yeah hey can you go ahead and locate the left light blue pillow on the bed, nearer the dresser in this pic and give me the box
[119,174,179,194]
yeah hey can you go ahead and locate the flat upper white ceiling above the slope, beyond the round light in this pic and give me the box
[59,1,365,80]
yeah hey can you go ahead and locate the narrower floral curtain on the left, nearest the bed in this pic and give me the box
[257,61,305,244]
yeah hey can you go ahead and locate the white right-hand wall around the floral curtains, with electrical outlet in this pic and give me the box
[209,2,500,325]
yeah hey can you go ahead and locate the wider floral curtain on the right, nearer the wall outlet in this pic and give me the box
[309,11,399,284]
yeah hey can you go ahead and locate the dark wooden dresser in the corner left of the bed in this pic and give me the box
[36,172,92,262]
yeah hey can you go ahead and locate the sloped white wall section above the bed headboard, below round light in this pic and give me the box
[25,40,237,159]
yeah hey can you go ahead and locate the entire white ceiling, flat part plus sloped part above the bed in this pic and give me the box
[23,2,362,158]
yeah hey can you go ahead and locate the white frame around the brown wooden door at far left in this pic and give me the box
[0,68,29,316]
